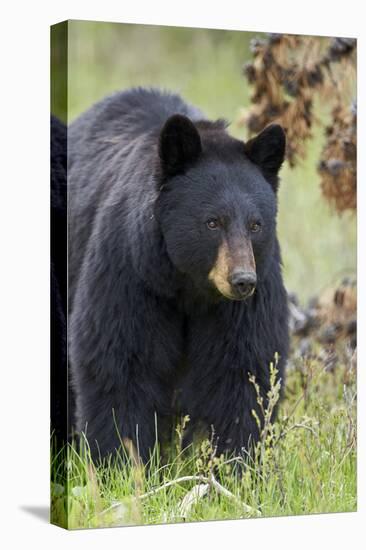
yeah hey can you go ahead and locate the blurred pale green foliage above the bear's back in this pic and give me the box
[68,21,252,121]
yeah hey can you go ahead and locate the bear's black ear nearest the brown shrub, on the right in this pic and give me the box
[245,124,286,191]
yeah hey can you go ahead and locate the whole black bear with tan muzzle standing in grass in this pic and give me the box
[68,88,288,461]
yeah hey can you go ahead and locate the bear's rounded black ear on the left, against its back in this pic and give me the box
[159,115,202,176]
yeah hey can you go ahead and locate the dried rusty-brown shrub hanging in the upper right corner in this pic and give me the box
[240,34,356,212]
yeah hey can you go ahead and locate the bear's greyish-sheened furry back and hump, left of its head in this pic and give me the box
[68,88,203,307]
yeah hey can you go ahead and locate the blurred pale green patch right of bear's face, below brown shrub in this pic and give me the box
[278,133,357,301]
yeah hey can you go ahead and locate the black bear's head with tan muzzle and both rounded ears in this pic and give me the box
[155,114,286,300]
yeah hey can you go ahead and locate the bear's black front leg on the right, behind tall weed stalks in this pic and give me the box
[183,300,287,456]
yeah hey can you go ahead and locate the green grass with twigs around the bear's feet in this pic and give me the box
[51,350,356,529]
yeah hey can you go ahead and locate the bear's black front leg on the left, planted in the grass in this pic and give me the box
[70,280,182,462]
